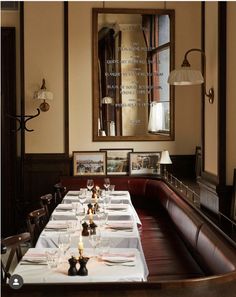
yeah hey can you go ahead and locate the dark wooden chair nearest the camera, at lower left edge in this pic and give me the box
[1,232,31,283]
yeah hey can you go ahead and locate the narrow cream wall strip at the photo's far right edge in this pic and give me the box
[226,1,236,185]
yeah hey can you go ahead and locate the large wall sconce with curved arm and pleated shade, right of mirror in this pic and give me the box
[168,48,214,104]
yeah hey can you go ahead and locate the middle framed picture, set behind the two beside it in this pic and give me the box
[100,149,133,175]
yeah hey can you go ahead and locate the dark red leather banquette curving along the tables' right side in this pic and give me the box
[60,176,236,281]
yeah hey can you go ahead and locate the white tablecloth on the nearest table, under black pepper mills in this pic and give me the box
[14,248,148,284]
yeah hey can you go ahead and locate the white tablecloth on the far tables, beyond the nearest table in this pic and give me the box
[33,191,148,280]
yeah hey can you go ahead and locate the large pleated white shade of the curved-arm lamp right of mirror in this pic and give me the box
[168,67,204,86]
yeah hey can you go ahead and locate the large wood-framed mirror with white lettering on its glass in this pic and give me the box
[93,9,174,141]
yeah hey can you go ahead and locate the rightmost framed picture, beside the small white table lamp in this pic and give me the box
[129,152,161,175]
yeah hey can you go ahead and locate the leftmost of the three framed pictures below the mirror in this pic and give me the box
[73,151,106,175]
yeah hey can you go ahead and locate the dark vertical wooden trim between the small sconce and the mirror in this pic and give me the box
[64,2,69,155]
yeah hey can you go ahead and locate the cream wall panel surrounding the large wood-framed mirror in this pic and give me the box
[69,1,201,154]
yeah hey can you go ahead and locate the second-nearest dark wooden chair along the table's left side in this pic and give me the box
[27,207,48,246]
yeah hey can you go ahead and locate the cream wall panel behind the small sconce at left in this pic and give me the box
[24,2,64,153]
